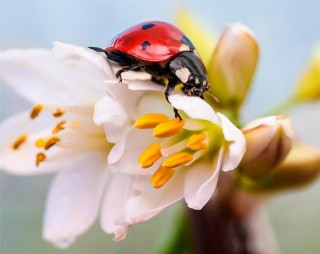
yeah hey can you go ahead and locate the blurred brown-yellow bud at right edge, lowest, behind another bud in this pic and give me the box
[253,144,320,192]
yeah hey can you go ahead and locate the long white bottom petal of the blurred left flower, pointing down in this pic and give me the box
[43,153,107,248]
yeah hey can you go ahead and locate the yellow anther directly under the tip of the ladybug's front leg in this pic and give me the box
[153,118,185,138]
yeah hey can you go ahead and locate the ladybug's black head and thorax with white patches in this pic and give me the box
[169,51,209,99]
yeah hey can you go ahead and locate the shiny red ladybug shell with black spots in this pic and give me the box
[105,21,194,62]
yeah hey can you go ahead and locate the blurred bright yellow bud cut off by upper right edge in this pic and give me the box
[294,47,320,101]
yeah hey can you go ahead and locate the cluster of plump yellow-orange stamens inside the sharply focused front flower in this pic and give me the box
[134,113,209,189]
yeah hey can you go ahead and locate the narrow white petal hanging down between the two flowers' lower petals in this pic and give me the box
[101,174,134,241]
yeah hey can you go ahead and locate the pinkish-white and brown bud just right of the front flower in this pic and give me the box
[240,116,293,179]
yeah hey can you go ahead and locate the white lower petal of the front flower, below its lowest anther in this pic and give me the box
[126,172,184,224]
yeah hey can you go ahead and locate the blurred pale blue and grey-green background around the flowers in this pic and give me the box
[0,0,320,254]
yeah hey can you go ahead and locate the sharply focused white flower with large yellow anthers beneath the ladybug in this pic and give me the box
[94,82,245,238]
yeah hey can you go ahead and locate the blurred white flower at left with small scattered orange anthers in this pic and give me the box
[0,43,134,248]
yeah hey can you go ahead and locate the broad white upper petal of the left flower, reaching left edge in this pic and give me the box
[0,49,105,106]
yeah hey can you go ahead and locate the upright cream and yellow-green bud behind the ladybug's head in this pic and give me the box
[208,24,259,110]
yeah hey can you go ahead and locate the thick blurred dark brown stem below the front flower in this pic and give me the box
[189,175,278,254]
